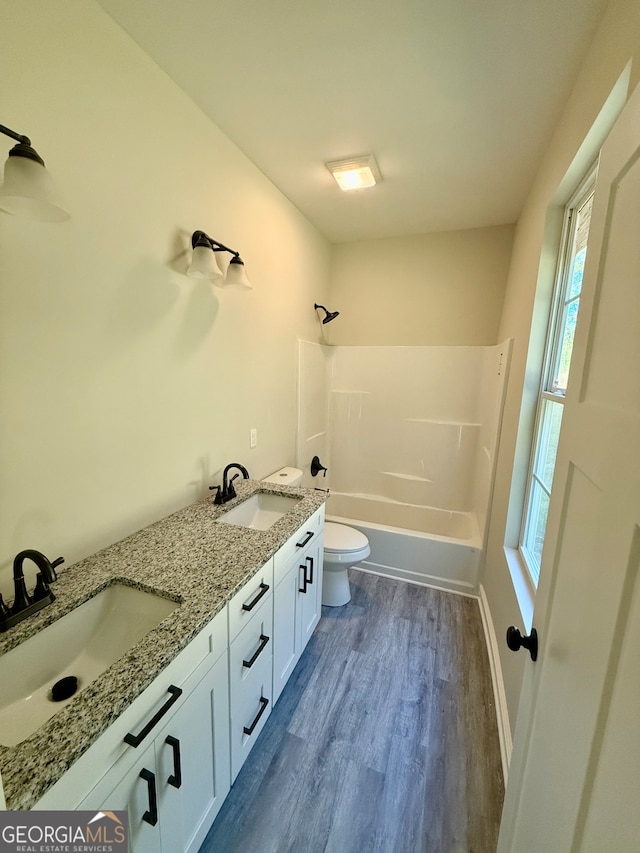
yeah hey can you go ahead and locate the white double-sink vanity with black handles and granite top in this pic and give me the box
[0,480,326,853]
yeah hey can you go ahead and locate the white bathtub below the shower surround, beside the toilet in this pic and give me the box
[326,492,482,594]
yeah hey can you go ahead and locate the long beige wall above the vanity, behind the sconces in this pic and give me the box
[0,0,330,597]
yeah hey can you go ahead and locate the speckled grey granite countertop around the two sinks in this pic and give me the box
[0,480,327,809]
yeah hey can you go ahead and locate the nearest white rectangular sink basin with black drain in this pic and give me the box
[0,584,179,746]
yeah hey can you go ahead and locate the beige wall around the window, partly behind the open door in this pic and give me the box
[483,0,640,729]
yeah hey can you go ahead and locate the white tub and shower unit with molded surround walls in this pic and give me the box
[297,341,511,594]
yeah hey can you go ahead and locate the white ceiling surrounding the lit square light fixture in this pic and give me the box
[99,0,606,242]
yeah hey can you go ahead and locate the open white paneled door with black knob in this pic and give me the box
[498,87,640,853]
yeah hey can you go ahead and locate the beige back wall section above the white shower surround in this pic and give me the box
[324,225,514,346]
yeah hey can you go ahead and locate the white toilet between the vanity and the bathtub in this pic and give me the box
[262,468,371,607]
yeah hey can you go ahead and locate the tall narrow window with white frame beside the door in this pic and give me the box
[520,167,596,587]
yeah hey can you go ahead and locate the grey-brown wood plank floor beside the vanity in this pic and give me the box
[200,570,504,853]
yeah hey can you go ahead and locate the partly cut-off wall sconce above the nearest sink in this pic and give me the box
[0,124,69,222]
